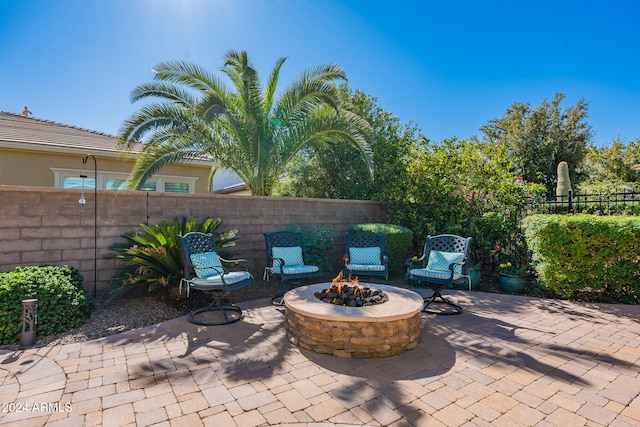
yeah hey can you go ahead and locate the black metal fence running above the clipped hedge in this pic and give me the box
[533,191,640,215]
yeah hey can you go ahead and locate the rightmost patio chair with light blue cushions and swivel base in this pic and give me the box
[405,234,471,314]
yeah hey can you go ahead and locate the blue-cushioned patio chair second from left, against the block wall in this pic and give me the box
[264,231,323,306]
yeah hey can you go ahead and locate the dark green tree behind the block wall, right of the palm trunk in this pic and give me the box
[276,84,422,200]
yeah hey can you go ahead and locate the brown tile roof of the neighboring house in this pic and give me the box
[0,111,139,152]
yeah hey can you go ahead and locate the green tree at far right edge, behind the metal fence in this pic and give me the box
[579,138,640,193]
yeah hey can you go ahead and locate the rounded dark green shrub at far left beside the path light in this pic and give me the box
[0,265,90,344]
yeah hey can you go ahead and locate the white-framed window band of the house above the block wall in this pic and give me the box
[51,168,198,193]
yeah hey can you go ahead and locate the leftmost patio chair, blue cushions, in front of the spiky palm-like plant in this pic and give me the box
[179,232,255,326]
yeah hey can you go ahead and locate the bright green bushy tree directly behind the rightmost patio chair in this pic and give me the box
[388,138,542,261]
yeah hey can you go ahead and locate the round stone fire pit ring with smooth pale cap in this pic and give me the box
[284,283,424,359]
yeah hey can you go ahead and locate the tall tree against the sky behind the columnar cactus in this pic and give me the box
[480,93,592,196]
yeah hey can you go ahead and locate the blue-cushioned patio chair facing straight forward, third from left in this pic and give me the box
[344,231,389,279]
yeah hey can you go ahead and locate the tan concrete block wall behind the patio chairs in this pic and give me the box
[0,185,385,293]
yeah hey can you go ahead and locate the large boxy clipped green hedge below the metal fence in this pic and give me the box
[523,215,640,304]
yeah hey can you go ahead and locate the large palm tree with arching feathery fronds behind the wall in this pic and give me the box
[118,51,372,196]
